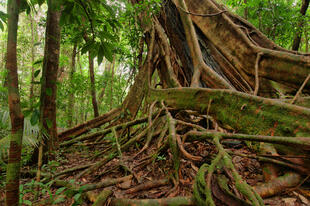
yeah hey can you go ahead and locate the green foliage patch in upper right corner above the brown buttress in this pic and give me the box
[224,0,310,49]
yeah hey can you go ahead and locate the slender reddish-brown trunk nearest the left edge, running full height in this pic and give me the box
[5,0,24,206]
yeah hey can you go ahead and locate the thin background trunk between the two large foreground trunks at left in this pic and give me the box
[29,12,36,110]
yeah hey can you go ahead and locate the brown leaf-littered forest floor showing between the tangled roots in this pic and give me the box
[0,136,310,206]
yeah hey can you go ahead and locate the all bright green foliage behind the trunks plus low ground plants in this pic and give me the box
[0,0,310,205]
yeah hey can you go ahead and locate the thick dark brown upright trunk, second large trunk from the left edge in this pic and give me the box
[40,0,61,158]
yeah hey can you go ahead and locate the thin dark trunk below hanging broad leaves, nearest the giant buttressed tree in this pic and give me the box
[88,52,99,118]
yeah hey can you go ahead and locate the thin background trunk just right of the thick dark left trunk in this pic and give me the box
[68,44,77,128]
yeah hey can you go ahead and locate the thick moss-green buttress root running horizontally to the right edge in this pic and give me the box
[147,88,310,137]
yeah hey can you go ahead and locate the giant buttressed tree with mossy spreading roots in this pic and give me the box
[60,0,310,205]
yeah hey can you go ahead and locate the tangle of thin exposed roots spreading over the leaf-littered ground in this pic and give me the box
[38,104,310,206]
